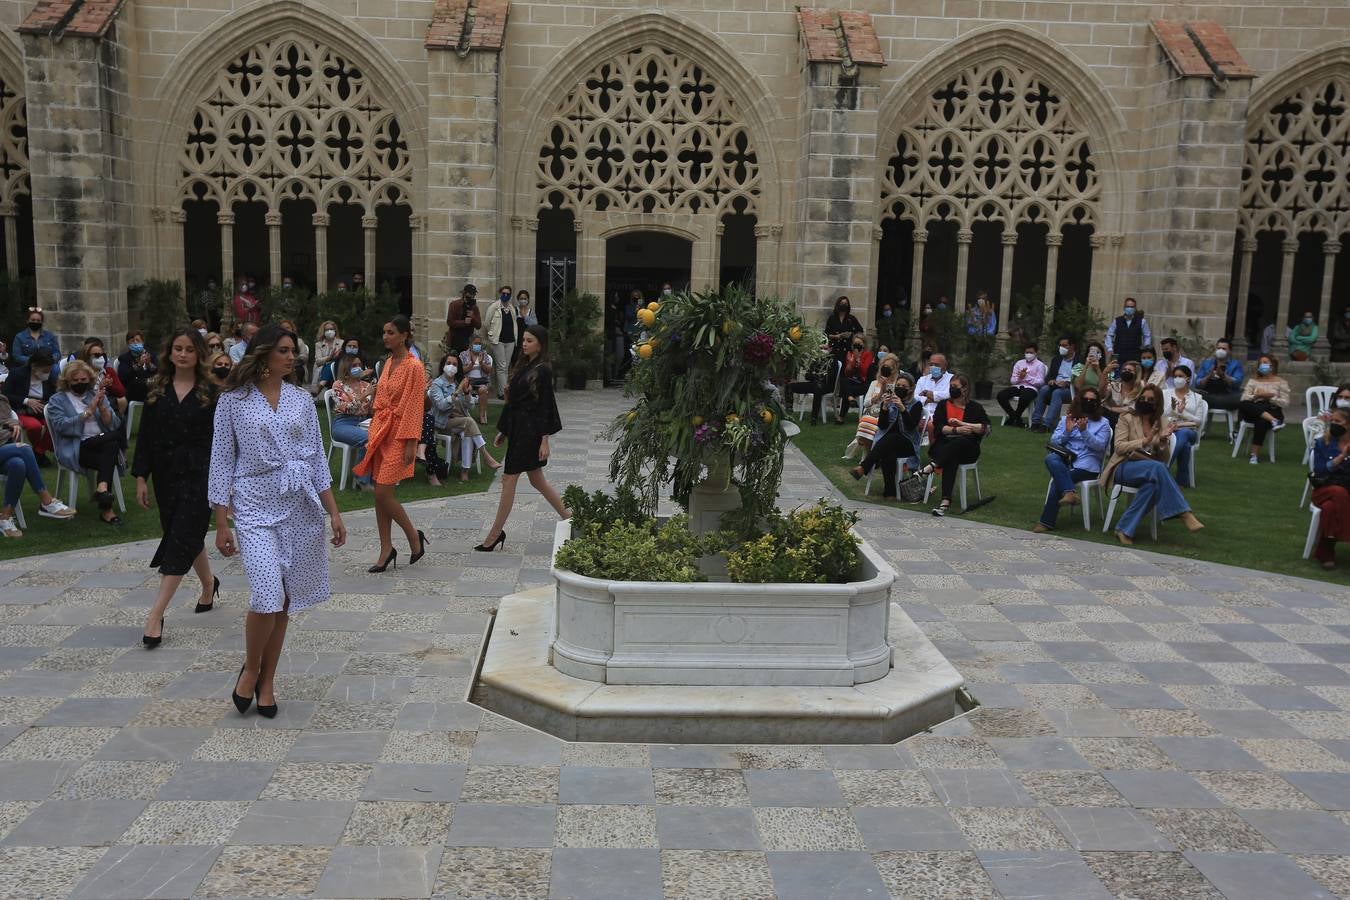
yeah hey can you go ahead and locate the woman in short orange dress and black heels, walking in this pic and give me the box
[352,316,427,572]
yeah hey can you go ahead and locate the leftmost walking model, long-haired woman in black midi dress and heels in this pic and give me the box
[131,328,220,648]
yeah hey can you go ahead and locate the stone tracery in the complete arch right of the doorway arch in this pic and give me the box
[882,62,1102,231]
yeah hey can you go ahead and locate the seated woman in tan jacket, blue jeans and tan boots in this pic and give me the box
[1102,385,1204,544]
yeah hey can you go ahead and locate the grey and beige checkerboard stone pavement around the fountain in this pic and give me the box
[0,393,1350,900]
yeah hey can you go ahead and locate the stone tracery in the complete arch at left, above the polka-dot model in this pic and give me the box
[181,38,412,215]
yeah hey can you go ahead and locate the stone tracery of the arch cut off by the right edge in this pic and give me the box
[1239,74,1350,240]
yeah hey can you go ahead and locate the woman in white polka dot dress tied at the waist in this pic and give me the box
[207,325,347,716]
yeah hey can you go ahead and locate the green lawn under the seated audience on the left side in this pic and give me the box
[0,403,505,559]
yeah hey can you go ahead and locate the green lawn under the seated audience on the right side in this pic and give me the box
[794,401,1350,584]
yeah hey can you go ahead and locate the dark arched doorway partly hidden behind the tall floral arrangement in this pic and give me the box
[605,231,694,375]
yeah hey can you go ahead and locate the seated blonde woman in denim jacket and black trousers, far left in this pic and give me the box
[47,360,122,525]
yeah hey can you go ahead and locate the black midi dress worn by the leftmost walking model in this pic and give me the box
[131,383,216,575]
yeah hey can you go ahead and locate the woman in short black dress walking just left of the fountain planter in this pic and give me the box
[474,325,571,551]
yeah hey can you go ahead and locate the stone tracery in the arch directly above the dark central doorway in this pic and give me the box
[536,46,760,215]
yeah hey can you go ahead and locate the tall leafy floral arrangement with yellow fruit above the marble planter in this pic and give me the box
[606,286,824,521]
